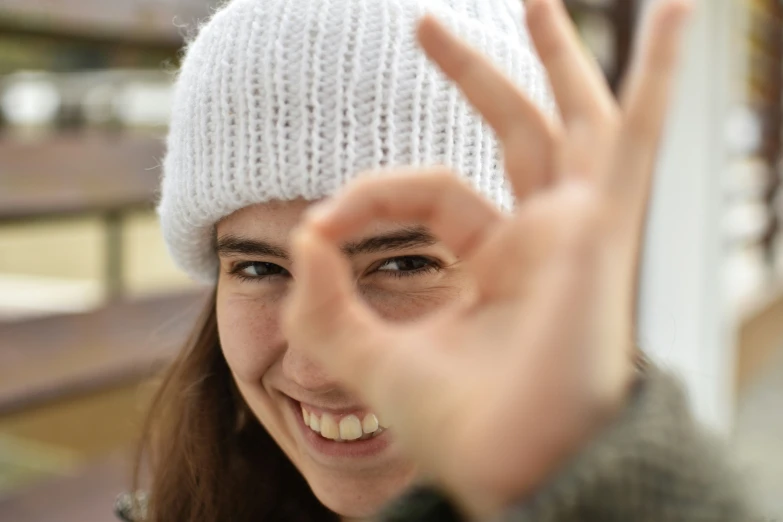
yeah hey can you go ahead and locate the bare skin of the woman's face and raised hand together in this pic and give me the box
[218,0,688,518]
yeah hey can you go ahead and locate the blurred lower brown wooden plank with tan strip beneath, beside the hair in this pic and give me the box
[0,292,205,470]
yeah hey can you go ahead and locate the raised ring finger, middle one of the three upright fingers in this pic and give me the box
[526,0,614,127]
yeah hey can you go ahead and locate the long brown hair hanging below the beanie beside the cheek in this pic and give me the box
[134,292,338,522]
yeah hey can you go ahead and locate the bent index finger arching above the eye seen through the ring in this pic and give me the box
[308,168,504,258]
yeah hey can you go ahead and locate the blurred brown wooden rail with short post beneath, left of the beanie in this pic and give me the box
[0,133,164,298]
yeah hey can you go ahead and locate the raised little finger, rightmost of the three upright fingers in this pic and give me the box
[607,0,690,214]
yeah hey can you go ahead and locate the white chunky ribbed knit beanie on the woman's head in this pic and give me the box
[158,0,552,282]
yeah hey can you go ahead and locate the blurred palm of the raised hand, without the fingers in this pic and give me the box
[376,187,633,504]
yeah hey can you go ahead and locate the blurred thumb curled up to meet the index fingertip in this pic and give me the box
[283,226,394,394]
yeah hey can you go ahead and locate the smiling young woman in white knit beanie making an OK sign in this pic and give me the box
[116,0,760,522]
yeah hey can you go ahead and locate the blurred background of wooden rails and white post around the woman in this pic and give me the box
[0,0,783,522]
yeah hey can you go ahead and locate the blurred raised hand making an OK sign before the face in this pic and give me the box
[284,0,689,515]
